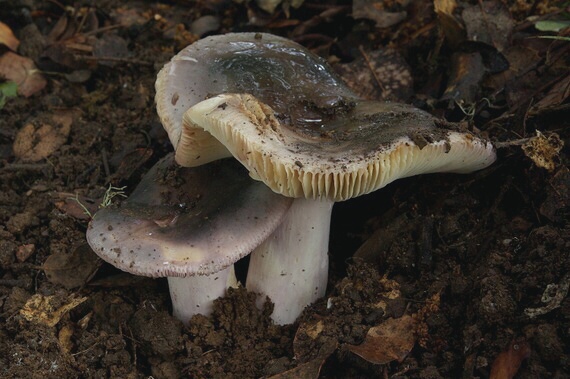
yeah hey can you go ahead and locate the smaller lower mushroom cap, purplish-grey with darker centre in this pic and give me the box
[87,154,292,277]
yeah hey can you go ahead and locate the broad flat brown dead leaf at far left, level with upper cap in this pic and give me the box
[13,111,73,162]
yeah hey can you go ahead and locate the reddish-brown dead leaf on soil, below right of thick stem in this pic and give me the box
[347,315,416,364]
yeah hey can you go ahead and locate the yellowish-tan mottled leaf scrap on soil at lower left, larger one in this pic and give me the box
[20,294,87,327]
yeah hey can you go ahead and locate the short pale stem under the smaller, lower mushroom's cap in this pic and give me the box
[168,265,237,324]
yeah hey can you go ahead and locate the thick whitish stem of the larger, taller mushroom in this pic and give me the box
[246,198,334,325]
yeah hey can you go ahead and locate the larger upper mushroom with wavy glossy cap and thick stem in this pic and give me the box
[157,33,495,324]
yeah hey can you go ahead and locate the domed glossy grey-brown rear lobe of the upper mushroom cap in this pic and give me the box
[155,33,357,166]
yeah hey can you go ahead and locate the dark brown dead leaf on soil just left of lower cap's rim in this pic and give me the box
[42,244,100,289]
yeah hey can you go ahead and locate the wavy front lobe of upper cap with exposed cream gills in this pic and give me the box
[184,94,496,201]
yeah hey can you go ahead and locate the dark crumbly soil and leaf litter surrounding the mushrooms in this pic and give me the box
[0,0,570,378]
